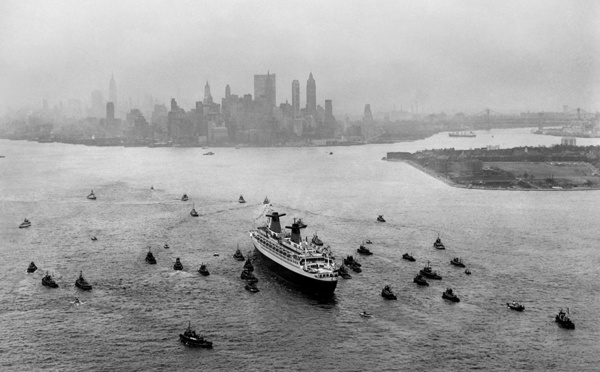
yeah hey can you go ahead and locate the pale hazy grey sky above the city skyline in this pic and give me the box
[0,0,600,115]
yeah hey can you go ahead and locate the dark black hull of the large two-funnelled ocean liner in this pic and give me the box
[252,239,337,295]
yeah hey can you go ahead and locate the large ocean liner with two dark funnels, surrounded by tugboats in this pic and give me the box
[250,212,338,294]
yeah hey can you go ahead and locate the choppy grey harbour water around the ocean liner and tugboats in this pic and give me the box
[0,130,600,371]
